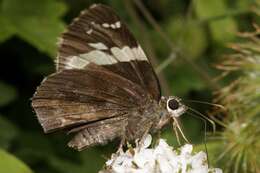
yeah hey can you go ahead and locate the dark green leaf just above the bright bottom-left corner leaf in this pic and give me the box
[0,115,18,149]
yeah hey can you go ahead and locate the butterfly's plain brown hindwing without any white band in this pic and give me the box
[32,64,148,132]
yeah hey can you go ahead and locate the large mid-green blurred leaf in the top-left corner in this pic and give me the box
[0,0,66,56]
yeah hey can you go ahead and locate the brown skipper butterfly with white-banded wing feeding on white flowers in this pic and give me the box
[32,4,187,150]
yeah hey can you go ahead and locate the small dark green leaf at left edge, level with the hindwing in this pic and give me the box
[0,81,17,107]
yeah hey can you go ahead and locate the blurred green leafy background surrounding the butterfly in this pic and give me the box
[0,0,260,173]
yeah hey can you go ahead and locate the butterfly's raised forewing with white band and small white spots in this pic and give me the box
[57,4,161,101]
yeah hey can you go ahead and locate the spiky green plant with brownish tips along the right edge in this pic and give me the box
[207,24,260,173]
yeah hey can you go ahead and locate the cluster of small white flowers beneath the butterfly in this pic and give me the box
[100,135,222,173]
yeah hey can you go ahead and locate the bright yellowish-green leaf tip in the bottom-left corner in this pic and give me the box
[0,149,32,173]
